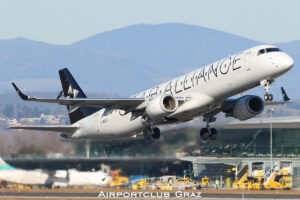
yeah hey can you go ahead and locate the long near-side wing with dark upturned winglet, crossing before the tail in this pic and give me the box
[12,83,145,110]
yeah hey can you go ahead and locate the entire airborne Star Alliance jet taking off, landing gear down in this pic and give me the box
[9,45,294,140]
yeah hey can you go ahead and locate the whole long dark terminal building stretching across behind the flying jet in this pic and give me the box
[6,122,300,187]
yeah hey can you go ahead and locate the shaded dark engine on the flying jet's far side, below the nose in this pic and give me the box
[232,95,264,121]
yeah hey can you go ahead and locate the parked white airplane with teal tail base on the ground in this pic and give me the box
[0,157,111,188]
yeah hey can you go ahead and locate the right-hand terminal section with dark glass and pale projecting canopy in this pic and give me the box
[181,129,300,187]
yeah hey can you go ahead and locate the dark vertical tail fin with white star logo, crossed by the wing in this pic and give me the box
[57,68,99,124]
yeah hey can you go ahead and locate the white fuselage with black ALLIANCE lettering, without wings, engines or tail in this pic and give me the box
[72,45,293,140]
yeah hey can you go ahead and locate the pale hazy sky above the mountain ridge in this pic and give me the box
[0,0,300,44]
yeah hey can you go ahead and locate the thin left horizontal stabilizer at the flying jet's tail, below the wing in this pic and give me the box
[8,125,80,132]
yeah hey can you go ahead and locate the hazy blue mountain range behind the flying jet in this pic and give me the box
[0,23,300,98]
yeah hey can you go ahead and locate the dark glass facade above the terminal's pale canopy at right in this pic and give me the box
[200,129,300,158]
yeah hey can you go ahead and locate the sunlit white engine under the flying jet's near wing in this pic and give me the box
[146,94,178,119]
